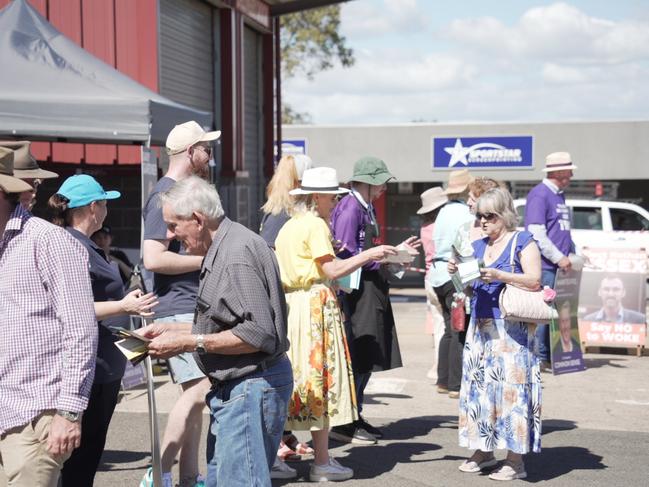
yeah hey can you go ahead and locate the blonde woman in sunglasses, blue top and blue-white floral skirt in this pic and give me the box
[448,188,541,480]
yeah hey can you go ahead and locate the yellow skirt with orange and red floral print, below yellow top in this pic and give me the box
[286,284,358,430]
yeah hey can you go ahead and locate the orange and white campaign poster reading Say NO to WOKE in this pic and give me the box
[579,248,647,348]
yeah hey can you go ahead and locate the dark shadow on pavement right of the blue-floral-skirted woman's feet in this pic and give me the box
[525,446,608,482]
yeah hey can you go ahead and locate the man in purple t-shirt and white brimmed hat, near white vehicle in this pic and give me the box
[525,152,577,369]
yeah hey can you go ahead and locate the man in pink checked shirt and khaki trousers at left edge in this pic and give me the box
[0,147,97,487]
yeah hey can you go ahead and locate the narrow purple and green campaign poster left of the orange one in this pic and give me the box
[550,269,586,375]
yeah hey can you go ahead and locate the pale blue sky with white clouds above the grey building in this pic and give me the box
[283,0,649,124]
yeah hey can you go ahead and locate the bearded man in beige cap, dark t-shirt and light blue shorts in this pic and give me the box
[143,121,221,487]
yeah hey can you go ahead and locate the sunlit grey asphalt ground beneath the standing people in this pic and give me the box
[0,297,649,487]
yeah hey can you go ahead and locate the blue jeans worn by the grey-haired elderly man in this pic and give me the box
[205,358,293,487]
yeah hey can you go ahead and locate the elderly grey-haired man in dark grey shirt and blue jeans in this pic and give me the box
[142,176,293,486]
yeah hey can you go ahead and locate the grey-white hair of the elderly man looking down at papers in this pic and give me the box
[160,176,225,222]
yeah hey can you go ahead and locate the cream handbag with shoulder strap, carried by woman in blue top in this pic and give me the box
[498,232,559,324]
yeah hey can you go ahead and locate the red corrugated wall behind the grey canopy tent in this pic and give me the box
[0,0,158,164]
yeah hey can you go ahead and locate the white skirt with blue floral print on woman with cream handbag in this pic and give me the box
[458,319,541,454]
